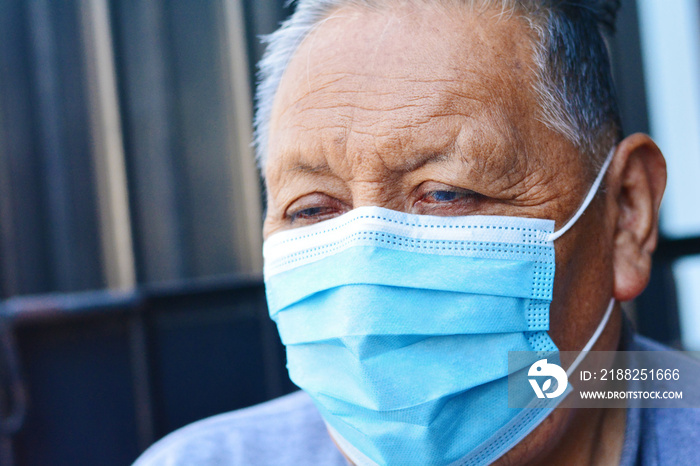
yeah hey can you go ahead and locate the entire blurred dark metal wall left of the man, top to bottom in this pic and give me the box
[0,0,292,466]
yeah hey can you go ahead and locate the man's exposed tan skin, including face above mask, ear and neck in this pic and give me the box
[264,4,665,464]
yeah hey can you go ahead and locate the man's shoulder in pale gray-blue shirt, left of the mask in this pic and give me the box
[134,392,345,466]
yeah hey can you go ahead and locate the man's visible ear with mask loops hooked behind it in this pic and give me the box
[608,133,666,301]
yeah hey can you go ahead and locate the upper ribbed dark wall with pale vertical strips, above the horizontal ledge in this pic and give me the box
[0,0,298,297]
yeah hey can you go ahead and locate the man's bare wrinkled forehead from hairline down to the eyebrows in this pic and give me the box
[266,2,576,184]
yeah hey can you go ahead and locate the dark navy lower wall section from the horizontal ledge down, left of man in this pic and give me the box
[0,276,294,465]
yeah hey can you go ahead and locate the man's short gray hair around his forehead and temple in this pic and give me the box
[255,0,621,173]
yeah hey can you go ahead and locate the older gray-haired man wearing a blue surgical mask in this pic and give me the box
[137,0,698,465]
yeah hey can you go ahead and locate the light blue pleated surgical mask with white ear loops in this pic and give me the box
[263,151,613,465]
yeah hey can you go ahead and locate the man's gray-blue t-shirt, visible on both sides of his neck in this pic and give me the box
[134,336,700,466]
